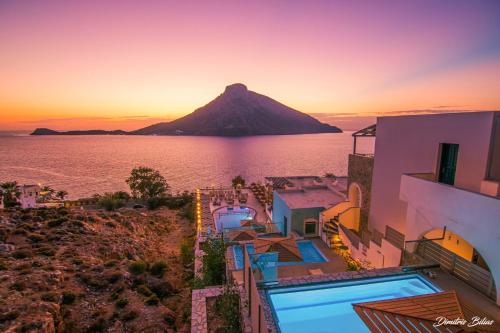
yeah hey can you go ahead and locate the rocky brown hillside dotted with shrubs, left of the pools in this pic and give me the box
[0,208,194,332]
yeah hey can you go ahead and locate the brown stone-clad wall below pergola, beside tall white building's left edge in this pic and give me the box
[347,154,374,230]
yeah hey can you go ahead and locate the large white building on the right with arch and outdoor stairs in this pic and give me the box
[323,112,500,304]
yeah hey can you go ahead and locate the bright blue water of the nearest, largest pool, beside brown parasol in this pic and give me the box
[267,274,441,333]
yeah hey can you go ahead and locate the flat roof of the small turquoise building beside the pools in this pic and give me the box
[276,187,346,209]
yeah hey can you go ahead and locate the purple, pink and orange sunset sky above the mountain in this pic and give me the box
[0,0,500,131]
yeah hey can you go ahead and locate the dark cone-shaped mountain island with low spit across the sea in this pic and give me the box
[31,83,342,136]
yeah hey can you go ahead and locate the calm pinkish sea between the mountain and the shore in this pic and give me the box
[0,132,374,198]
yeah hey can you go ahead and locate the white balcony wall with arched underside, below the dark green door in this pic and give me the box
[401,175,500,305]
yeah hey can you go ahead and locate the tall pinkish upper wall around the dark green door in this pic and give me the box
[369,112,495,240]
